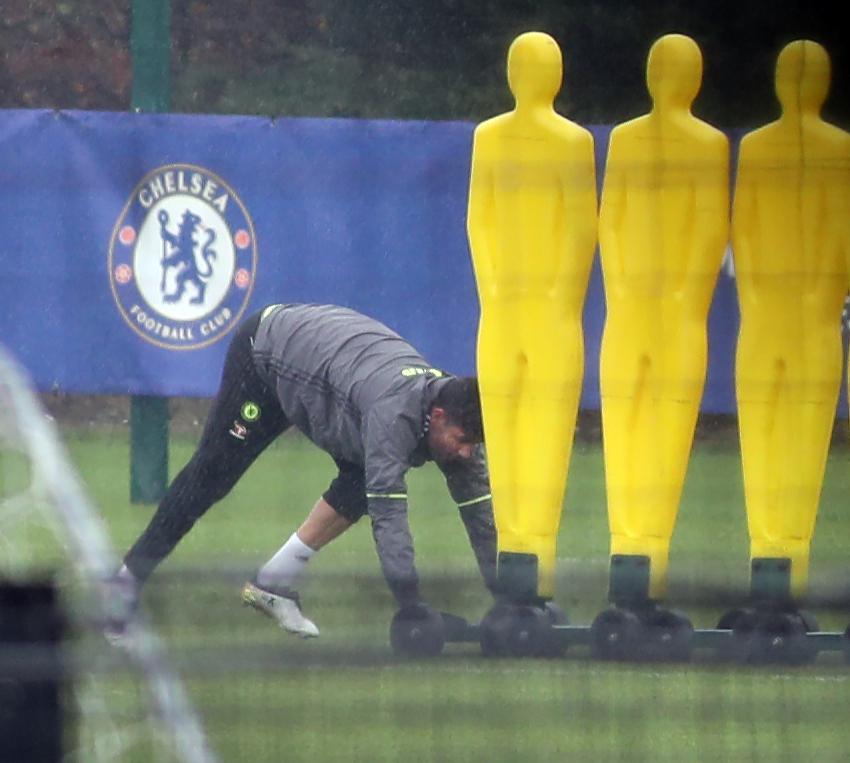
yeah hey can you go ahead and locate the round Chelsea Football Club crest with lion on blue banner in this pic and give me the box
[109,164,257,350]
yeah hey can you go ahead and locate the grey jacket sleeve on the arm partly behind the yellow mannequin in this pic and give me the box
[441,445,498,596]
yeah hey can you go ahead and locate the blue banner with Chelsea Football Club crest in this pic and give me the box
[0,110,844,413]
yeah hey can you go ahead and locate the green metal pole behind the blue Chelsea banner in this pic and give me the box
[130,0,171,503]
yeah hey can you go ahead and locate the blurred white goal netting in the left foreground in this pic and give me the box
[0,346,216,763]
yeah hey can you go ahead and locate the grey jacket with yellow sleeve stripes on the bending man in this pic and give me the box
[254,304,496,606]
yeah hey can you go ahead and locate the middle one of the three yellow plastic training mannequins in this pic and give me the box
[599,34,729,602]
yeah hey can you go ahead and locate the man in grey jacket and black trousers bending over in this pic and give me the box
[107,304,496,639]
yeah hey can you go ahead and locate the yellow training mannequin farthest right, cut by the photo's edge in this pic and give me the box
[732,40,850,597]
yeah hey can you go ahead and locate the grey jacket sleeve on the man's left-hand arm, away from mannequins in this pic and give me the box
[365,402,420,606]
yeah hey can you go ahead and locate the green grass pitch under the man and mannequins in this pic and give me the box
[49,431,850,763]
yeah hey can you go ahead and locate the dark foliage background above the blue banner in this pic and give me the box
[0,0,850,127]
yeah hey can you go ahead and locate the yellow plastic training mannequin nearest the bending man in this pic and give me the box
[468,32,596,598]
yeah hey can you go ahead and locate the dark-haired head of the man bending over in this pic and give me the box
[428,376,484,462]
